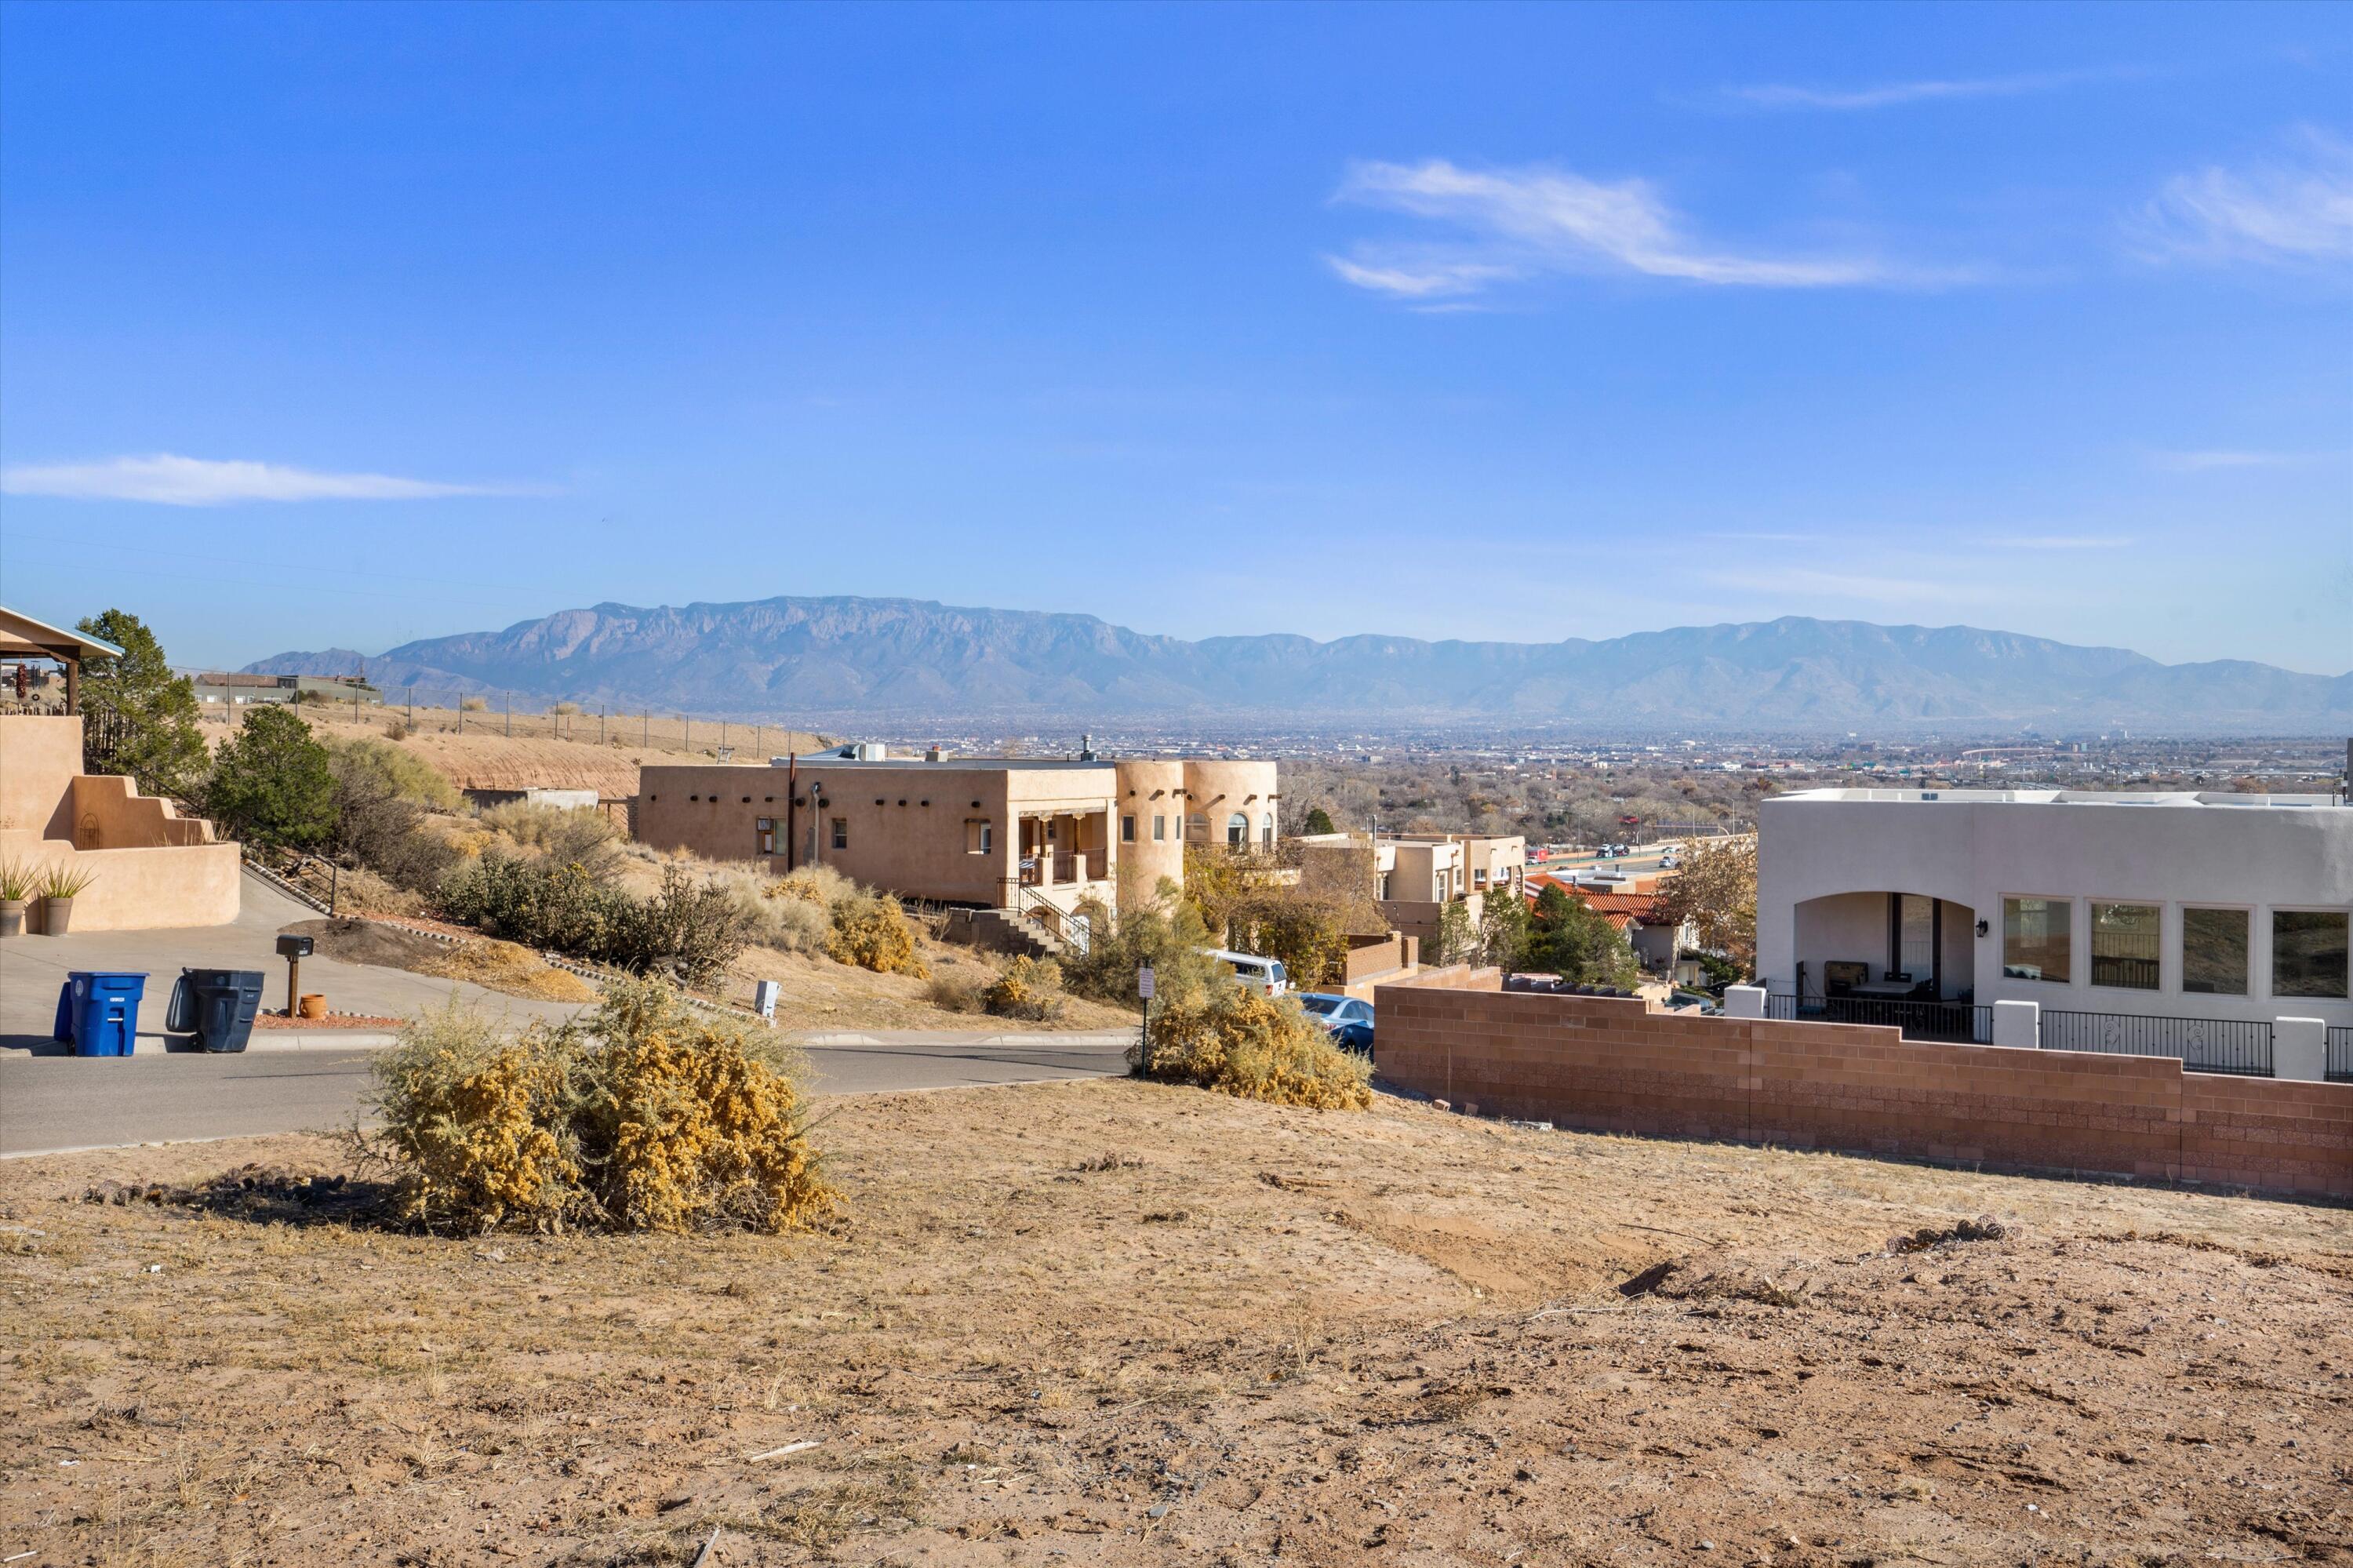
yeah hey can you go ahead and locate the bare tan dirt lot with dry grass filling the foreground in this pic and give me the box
[0,1081,2353,1568]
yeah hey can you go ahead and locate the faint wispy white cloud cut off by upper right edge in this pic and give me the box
[2129,129,2353,266]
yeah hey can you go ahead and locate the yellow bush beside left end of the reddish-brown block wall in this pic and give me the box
[1129,987,1372,1111]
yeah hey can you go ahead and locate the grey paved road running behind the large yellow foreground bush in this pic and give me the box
[0,1031,1129,1156]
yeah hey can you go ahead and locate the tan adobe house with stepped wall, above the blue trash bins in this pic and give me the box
[0,607,240,933]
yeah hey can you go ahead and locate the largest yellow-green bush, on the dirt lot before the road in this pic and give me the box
[372,982,838,1231]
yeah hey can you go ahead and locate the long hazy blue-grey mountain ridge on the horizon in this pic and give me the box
[247,595,2353,734]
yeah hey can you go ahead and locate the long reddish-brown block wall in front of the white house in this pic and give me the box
[1374,968,2353,1199]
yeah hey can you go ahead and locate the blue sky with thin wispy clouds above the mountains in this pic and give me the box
[0,2,2353,673]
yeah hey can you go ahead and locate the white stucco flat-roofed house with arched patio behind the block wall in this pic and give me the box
[1758,789,2353,1057]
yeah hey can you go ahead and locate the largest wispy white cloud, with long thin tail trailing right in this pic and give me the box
[1327,158,1965,304]
